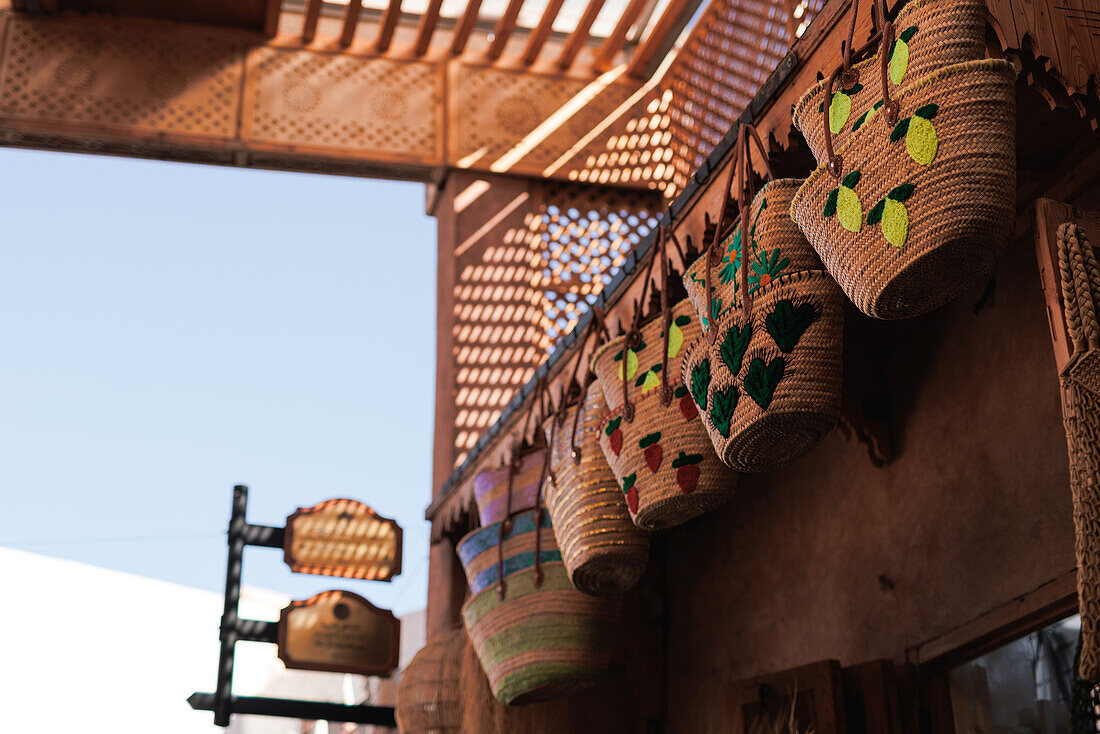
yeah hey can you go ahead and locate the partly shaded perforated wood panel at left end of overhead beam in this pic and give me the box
[0,15,244,138]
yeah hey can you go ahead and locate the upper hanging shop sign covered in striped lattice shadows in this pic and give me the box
[284,500,402,581]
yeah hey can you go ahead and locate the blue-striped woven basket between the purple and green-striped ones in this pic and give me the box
[458,510,561,594]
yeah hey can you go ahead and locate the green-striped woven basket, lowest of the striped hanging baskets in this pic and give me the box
[462,562,619,705]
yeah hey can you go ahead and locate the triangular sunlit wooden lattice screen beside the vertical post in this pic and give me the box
[453,179,660,464]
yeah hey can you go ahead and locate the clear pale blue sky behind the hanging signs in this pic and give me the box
[0,150,436,614]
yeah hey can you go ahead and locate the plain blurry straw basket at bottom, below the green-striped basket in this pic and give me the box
[394,628,466,734]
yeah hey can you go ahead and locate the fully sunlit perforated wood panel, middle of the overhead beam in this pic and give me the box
[241,48,443,161]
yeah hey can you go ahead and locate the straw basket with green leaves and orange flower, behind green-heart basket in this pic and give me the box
[684,178,822,330]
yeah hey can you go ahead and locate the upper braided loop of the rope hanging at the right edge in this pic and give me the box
[1058,221,1100,354]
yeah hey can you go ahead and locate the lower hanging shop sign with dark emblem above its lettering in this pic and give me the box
[278,591,402,676]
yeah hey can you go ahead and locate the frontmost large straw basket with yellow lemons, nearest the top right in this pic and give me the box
[791,59,1015,319]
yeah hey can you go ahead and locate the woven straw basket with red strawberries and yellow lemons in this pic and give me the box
[592,298,737,529]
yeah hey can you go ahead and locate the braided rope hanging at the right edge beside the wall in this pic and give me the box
[1058,222,1100,681]
